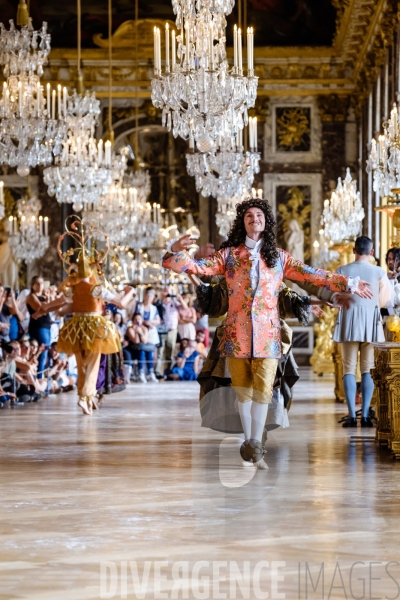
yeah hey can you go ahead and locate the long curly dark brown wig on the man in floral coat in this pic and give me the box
[221,198,279,269]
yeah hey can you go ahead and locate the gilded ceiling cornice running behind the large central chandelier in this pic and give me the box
[35,0,399,101]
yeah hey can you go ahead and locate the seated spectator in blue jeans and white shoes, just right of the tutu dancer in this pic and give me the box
[126,313,158,383]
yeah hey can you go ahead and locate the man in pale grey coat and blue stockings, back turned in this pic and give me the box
[323,236,392,427]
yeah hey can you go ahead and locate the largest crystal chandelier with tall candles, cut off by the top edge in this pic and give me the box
[152,0,258,152]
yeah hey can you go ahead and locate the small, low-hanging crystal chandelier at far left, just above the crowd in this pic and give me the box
[8,198,49,264]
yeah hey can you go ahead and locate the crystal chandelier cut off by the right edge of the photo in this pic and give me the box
[367,104,400,199]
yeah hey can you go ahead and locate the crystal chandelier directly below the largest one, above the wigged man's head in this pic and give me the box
[186,118,260,198]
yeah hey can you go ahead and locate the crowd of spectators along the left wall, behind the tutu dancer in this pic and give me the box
[0,276,209,407]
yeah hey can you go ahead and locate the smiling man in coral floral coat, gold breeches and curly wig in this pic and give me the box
[163,199,371,469]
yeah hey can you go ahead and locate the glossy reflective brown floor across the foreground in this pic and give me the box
[0,369,400,600]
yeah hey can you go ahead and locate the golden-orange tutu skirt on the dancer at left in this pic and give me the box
[57,315,121,354]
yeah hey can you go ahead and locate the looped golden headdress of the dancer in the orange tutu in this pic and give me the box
[57,215,110,278]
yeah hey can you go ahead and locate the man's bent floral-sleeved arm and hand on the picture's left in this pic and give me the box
[162,235,228,275]
